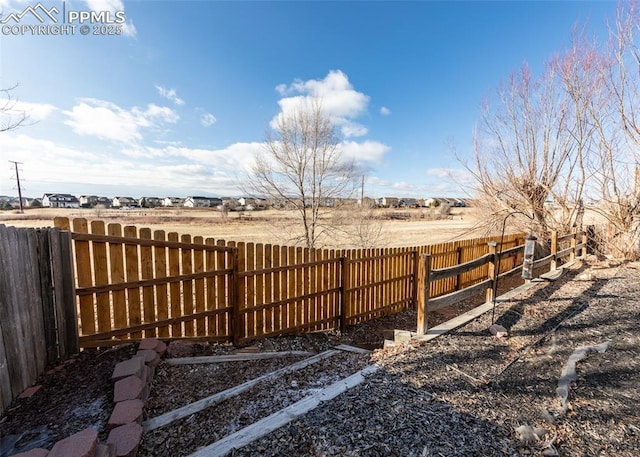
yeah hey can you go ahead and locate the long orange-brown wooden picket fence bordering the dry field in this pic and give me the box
[54,218,524,347]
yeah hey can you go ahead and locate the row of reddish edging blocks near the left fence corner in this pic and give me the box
[14,338,167,457]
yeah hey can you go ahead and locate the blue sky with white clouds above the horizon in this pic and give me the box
[0,0,616,197]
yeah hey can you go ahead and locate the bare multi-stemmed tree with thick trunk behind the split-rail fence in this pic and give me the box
[468,62,576,236]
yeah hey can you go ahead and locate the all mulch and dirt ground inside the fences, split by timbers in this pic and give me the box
[0,259,640,457]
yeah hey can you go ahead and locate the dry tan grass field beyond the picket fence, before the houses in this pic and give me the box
[0,208,487,248]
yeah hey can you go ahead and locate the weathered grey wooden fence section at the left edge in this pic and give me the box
[0,225,78,414]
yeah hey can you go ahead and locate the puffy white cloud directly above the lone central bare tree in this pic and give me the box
[271,70,369,138]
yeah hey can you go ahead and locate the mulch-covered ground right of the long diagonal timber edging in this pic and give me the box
[233,263,640,457]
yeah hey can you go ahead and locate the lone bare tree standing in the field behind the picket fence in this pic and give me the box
[246,101,355,248]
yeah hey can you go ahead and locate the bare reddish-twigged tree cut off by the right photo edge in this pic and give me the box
[592,2,640,258]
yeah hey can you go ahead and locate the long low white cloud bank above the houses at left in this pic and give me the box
[0,133,263,197]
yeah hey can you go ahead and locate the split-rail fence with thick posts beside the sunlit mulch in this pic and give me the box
[417,230,587,334]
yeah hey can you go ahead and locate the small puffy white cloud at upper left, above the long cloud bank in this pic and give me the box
[63,99,180,143]
